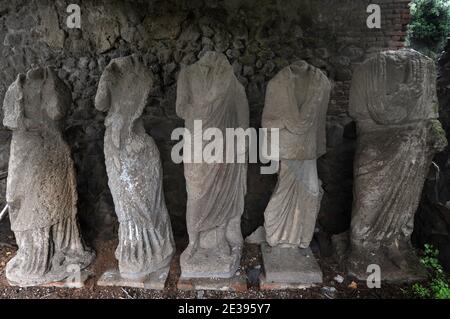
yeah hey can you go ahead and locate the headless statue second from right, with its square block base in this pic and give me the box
[262,61,331,290]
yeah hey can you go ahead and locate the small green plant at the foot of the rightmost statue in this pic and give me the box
[411,244,450,299]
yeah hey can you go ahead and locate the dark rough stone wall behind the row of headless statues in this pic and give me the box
[0,0,409,245]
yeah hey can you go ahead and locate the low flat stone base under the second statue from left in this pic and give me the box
[97,266,170,290]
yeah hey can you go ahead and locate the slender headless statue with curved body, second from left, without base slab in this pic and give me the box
[95,55,175,288]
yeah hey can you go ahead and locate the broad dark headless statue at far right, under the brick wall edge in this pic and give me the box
[347,49,446,281]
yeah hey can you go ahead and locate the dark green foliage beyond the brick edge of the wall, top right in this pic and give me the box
[408,0,450,55]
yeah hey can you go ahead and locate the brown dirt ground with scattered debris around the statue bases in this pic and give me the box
[0,222,410,299]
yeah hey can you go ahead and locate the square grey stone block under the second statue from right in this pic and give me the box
[260,244,322,290]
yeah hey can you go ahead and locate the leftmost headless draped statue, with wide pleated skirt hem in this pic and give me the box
[3,68,94,286]
